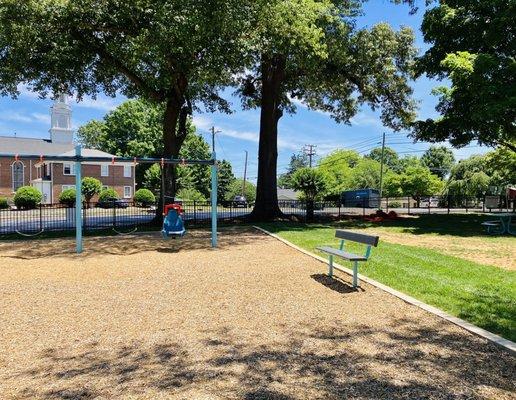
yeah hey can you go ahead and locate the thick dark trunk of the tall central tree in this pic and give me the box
[251,55,285,221]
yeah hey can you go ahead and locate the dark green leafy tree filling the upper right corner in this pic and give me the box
[413,0,516,151]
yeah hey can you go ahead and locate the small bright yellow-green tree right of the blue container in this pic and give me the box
[400,166,444,207]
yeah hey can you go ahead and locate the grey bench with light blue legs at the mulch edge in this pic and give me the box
[316,229,380,289]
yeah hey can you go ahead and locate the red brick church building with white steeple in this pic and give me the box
[0,95,135,204]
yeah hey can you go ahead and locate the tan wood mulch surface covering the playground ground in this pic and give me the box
[0,228,516,400]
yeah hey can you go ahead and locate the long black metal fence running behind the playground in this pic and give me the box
[0,196,516,237]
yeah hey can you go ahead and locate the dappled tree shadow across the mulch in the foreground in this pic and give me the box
[9,317,516,400]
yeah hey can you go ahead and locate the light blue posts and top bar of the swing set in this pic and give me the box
[0,146,217,253]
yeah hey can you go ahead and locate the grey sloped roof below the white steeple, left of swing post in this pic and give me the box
[0,136,74,156]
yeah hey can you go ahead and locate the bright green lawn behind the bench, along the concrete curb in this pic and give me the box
[260,221,516,341]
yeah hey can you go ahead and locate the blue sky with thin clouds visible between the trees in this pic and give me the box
[0,0,489,181]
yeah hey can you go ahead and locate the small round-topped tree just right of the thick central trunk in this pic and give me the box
[292,168,328,221]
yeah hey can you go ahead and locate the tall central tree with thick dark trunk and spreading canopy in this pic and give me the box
[239,0,415,219]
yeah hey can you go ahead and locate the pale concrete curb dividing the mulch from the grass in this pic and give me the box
[253,226,516,353]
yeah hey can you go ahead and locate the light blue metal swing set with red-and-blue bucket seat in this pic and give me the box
[0,146,217,254]
